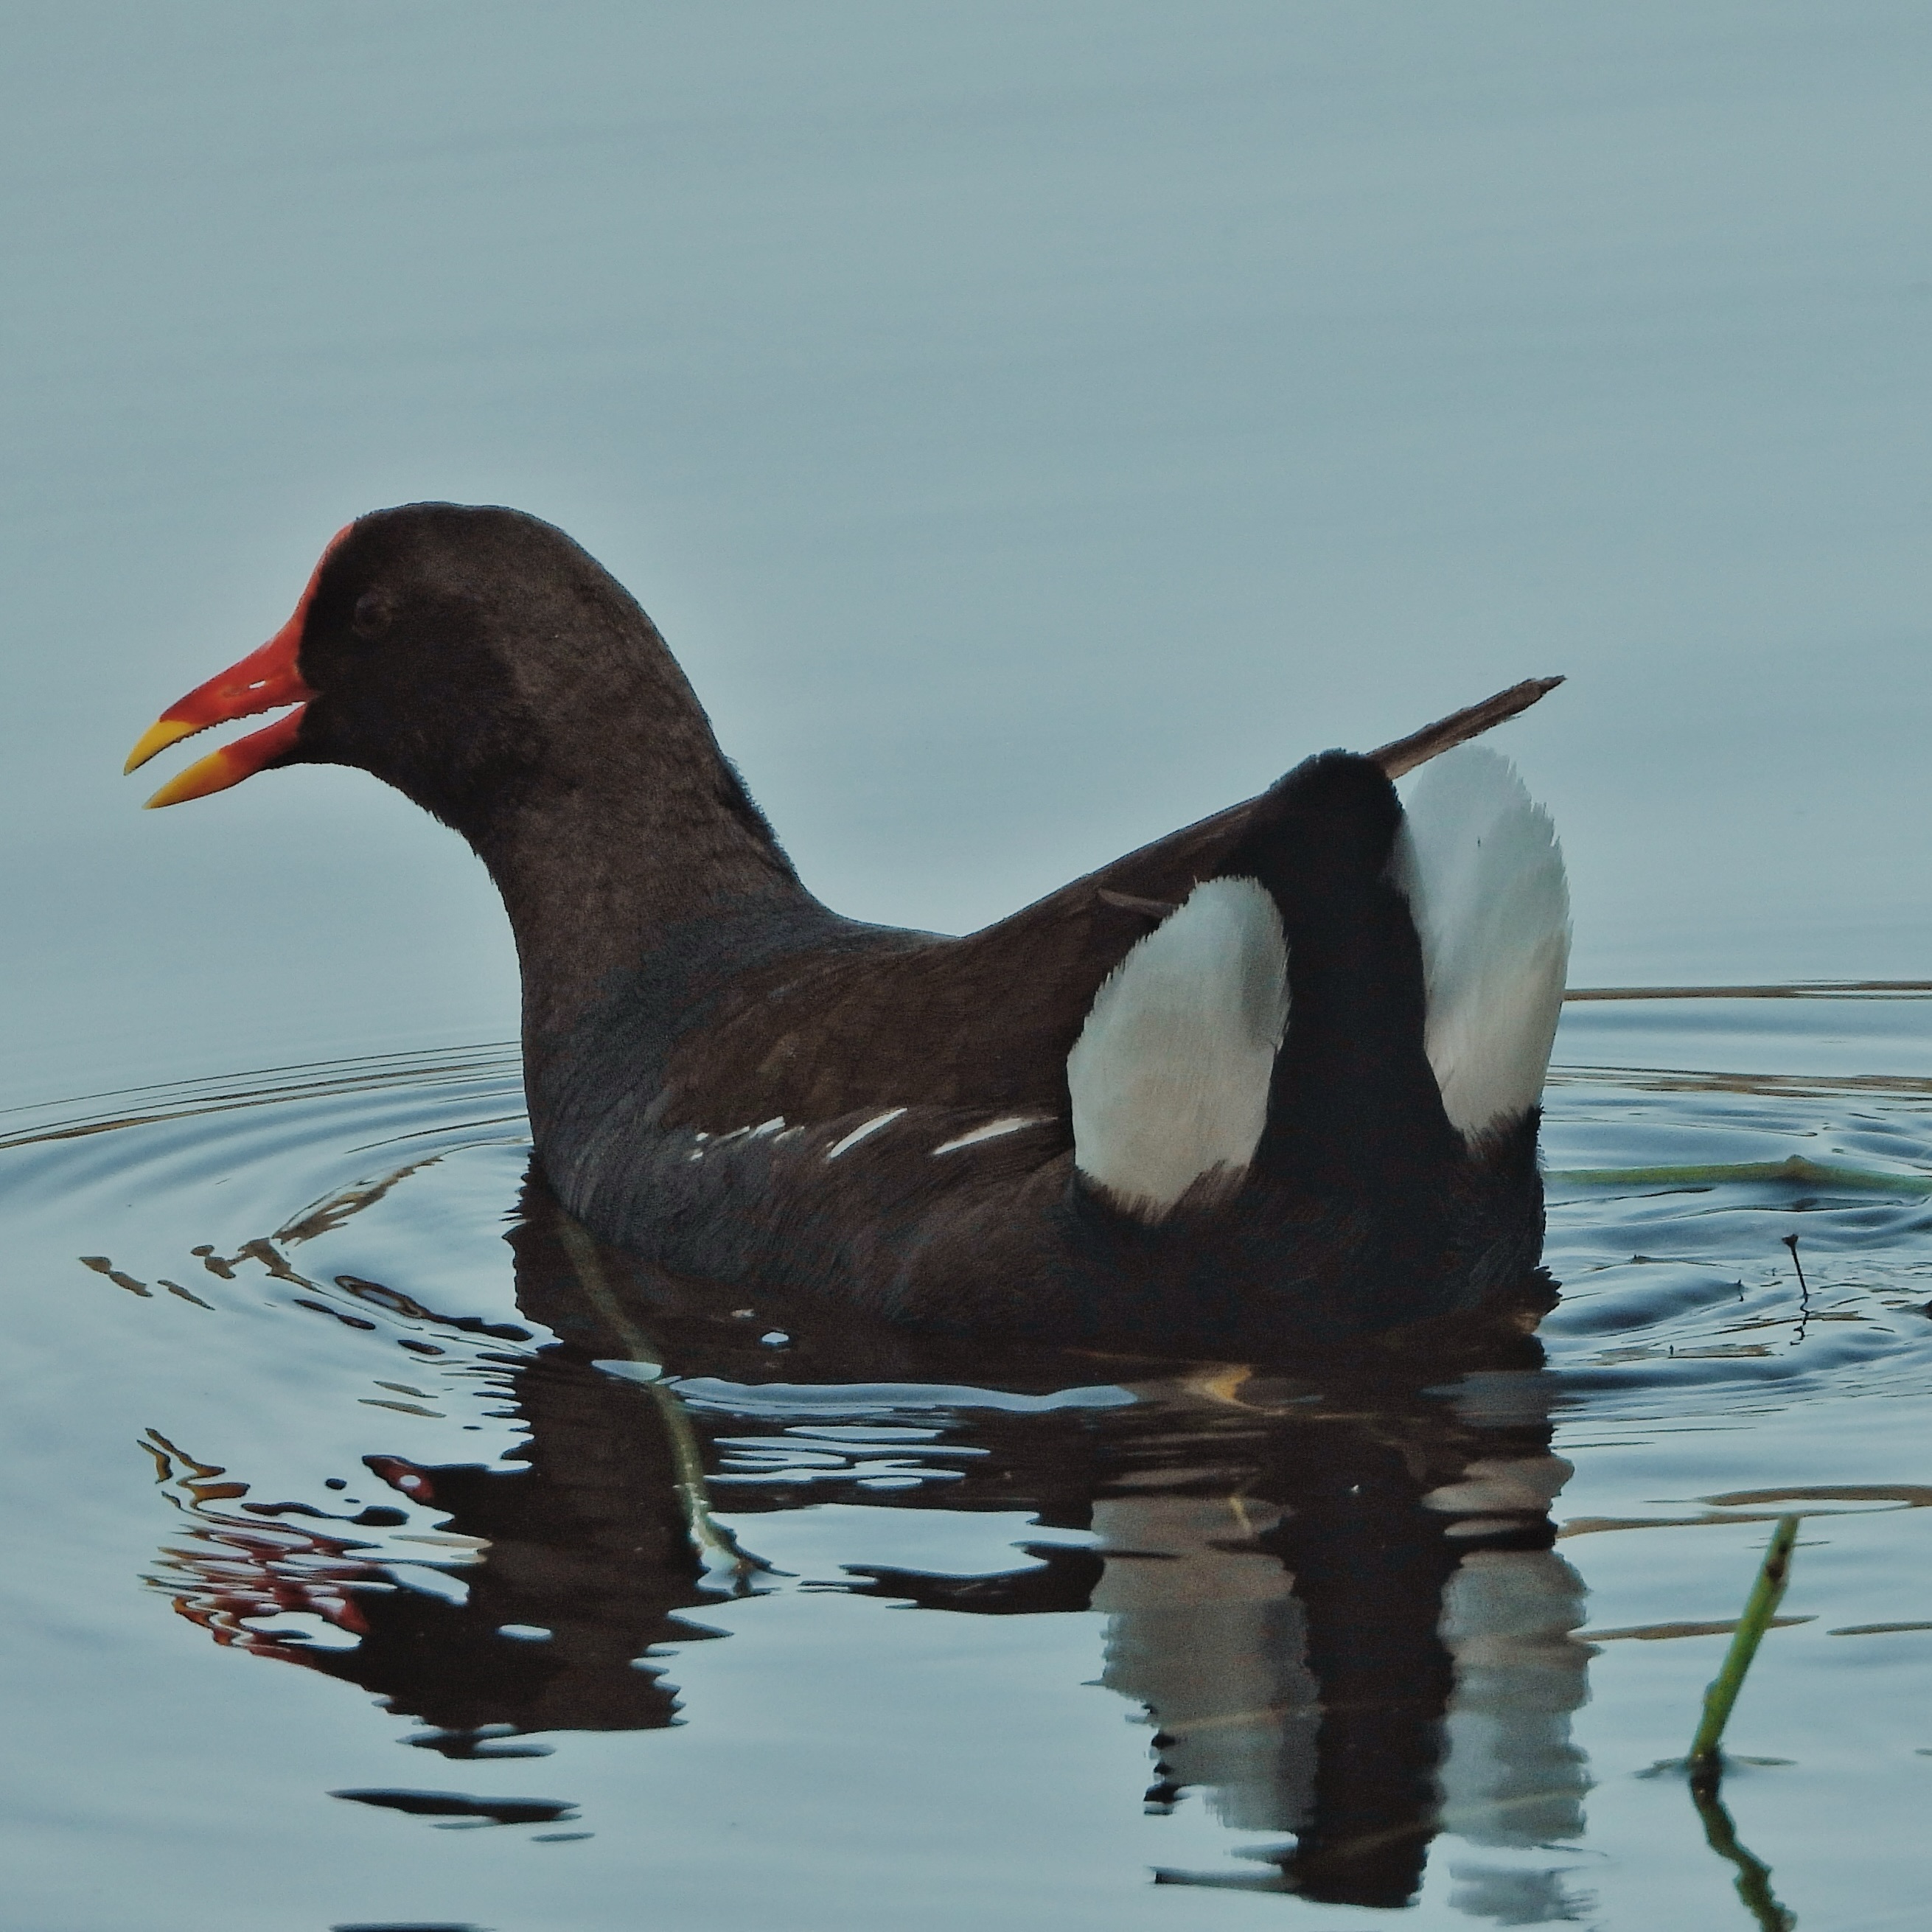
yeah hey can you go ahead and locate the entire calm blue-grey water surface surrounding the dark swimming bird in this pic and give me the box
[0,15,1932,1932]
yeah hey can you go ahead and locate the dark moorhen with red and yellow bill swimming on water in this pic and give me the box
[128,504,1569,1359]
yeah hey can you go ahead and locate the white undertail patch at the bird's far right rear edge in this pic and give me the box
[1391,744,1571,1142]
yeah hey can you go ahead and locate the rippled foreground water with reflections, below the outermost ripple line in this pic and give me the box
[0,997,1932,1932]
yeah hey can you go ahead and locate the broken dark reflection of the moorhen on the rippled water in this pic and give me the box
[150,1185,1590,1925]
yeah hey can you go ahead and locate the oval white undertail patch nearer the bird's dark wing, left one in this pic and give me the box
[1067,879,1288,1221]
